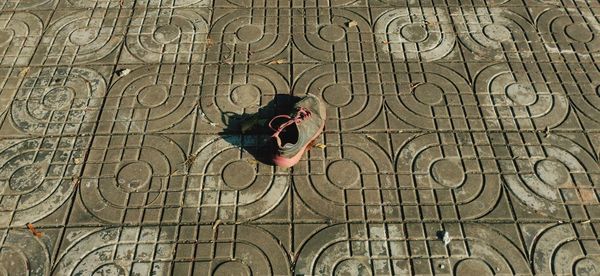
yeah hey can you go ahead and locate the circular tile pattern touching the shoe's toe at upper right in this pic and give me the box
[293,64,383,130]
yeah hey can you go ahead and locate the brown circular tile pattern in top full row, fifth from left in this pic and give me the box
[292,9,375,63]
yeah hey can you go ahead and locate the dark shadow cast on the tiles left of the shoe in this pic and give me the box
[219,94,300,165]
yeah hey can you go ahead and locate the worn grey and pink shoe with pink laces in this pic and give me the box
[269,94,325,168]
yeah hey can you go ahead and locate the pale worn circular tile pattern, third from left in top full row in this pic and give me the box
[125,9,209,63]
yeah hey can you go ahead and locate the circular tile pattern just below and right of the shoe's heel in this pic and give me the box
[293,134,396,220]
